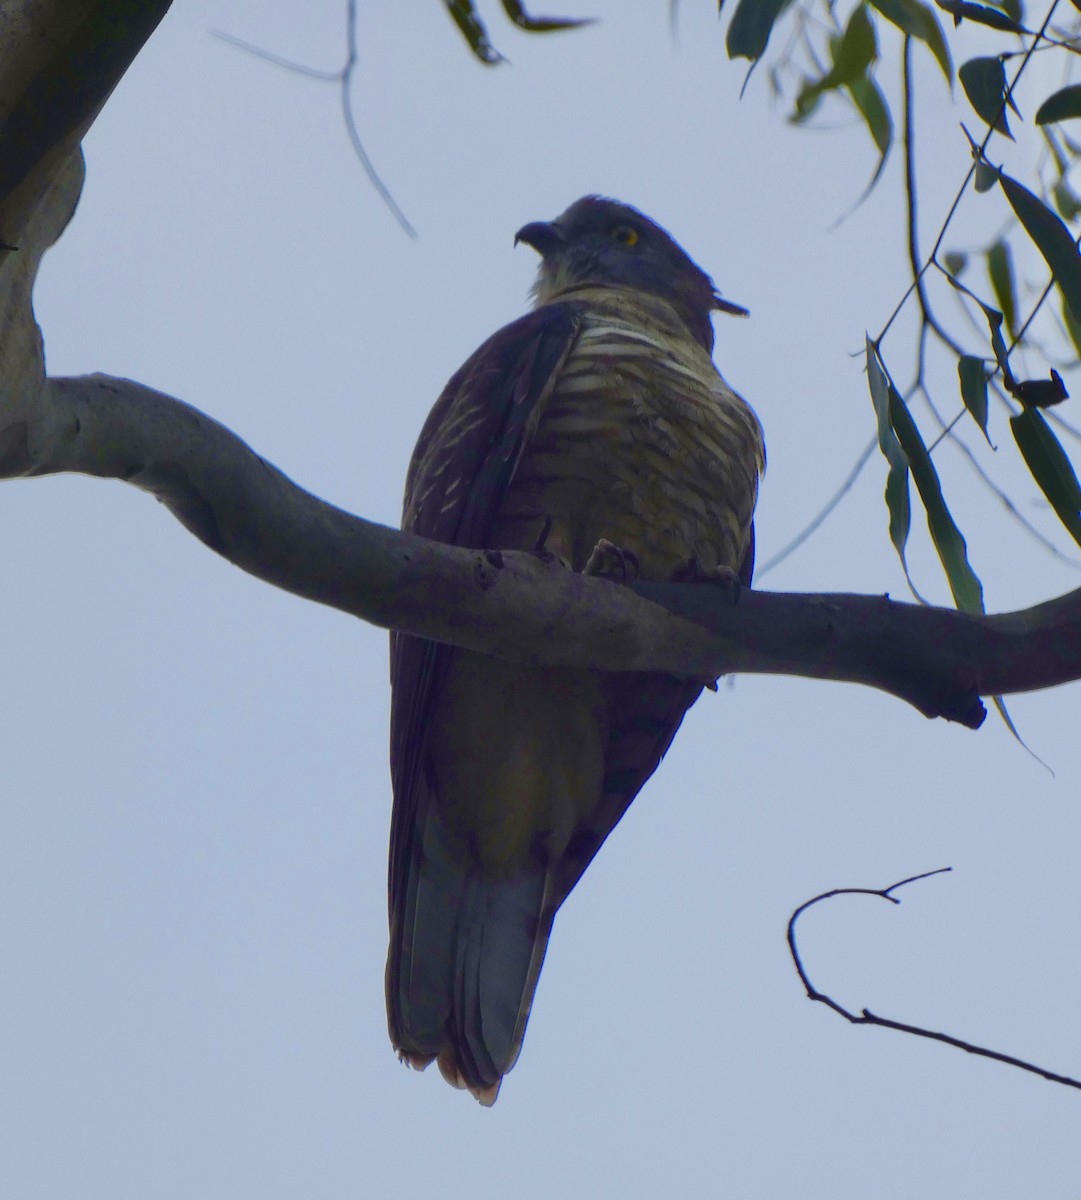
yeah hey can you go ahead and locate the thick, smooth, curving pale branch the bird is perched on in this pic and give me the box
[0,376,1081,727]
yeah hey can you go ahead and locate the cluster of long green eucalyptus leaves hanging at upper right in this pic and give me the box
[721,0,1081,611]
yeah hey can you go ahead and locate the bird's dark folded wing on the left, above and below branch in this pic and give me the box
[389,302,579,954]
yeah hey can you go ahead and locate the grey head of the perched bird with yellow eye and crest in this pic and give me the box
[515,196,747,350]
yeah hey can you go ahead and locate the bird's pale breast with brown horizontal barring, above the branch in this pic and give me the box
[493,302,763,578]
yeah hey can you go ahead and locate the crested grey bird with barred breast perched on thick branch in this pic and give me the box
[386,196,765,1106]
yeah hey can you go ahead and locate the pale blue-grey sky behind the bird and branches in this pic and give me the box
[0,0,1081,1200]
